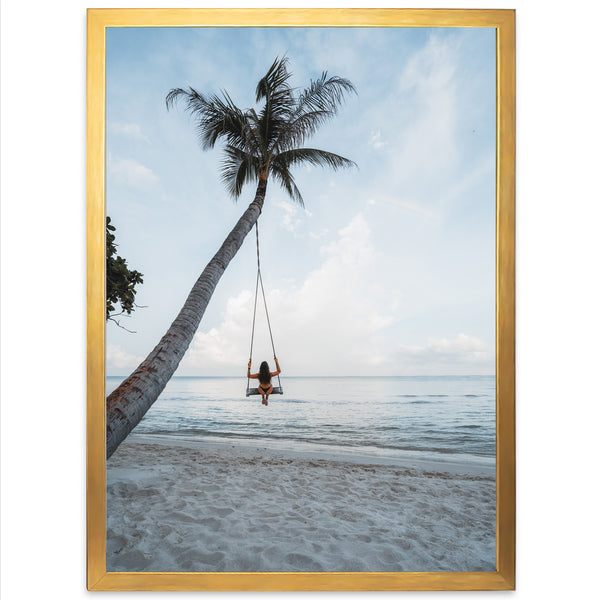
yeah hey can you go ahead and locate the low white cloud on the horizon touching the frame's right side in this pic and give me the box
[394,333,494,375]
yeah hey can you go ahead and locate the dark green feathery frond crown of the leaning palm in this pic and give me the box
[166,57,356,206]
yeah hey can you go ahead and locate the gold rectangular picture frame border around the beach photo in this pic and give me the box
[87,9,515,591]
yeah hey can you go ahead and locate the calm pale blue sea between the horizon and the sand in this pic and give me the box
[107,376,496,462]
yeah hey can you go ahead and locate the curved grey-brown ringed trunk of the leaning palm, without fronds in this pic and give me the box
[106,178,267,458]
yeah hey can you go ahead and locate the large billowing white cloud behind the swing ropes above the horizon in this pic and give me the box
[182,214,394,375]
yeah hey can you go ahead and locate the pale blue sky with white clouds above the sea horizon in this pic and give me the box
[106,28,495,375]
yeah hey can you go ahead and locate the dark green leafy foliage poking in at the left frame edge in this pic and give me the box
[106,217,144,325]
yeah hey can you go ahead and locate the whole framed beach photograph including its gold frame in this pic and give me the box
[87,9,515,590]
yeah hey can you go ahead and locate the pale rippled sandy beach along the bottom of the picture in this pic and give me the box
[107,435,495,571]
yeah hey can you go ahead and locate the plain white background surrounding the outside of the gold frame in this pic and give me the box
[2,0,600,600]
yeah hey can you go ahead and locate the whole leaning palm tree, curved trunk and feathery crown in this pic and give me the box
[106,57,355,458]
